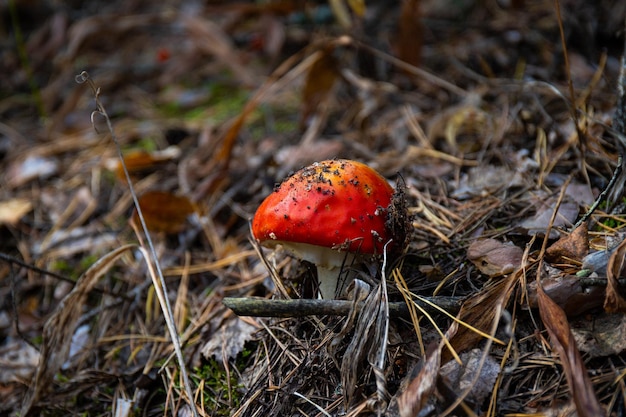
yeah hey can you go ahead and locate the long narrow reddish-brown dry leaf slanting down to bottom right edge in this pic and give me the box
[537,285,604,417]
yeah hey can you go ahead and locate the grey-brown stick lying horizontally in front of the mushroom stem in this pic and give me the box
[222,297,463,317]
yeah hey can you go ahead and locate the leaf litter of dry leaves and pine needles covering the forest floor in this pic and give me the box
[0,0,626,416]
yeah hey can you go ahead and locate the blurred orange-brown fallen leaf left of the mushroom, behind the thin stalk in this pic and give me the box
[133,191,194,234]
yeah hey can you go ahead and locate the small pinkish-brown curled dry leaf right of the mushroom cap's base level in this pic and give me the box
[467,239,524,277]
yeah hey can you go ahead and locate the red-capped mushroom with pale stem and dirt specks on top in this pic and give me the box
[252,159,394,298]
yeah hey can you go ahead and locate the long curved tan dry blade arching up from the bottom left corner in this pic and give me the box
[20,245,135,417]
